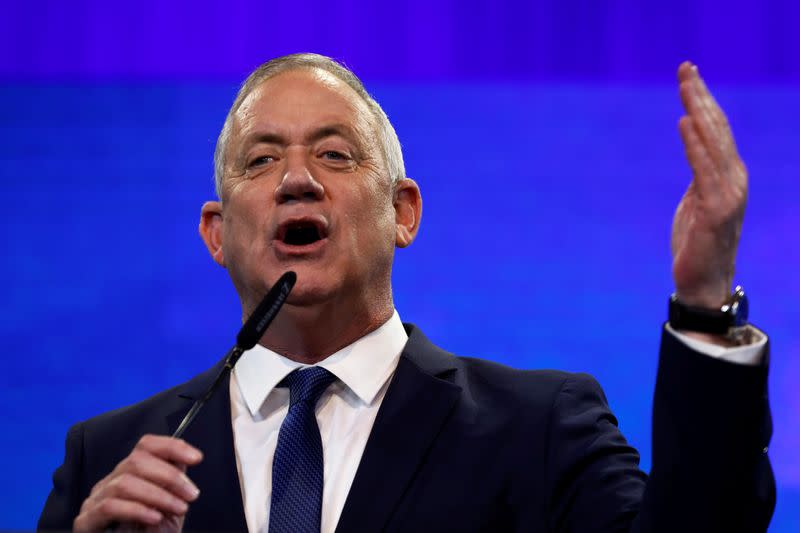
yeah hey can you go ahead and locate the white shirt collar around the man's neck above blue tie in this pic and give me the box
[233,310,408,416]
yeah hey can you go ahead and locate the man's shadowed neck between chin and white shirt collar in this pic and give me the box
[247,296,394,365]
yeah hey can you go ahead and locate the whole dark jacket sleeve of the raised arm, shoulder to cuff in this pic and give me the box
[546,324,775,533]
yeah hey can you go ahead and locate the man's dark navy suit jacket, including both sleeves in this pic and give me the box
[39,326,775,533]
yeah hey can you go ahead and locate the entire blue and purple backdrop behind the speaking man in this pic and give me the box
[0,0,800,532]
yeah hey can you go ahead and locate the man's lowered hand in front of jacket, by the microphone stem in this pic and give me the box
[73,435,203,532]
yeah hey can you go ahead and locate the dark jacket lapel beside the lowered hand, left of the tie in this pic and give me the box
[167,361,247,531]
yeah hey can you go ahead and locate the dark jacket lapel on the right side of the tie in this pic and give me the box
[336,326,461,533]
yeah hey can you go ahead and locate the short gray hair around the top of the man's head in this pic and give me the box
[214,54,406,198]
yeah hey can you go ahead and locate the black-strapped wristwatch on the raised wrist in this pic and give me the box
[669,285,748,338]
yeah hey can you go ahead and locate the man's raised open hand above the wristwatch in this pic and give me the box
[672,62,747,308]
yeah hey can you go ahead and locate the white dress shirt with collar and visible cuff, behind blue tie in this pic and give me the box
[230,311,767,533]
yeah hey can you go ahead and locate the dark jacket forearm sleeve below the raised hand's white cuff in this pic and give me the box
[636,326,775,532]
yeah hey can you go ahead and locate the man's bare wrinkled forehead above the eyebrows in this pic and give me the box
[234,69,370,143]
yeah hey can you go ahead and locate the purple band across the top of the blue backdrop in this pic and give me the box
[0,0,800,83]
